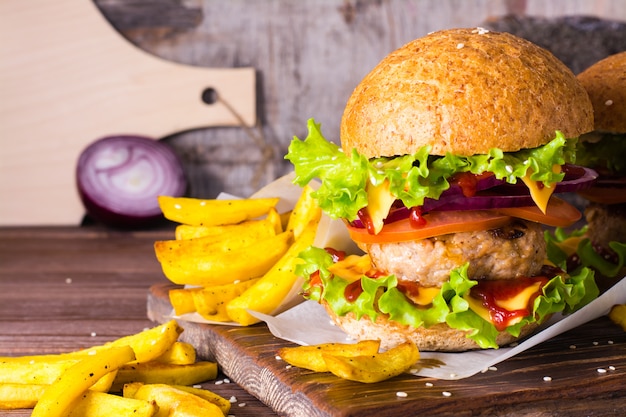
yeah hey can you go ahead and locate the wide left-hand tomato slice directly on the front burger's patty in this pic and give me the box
[348,210,511,243]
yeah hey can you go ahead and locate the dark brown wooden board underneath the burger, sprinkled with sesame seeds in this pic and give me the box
[147,284,626,417]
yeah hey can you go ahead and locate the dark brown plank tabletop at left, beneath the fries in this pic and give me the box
[0,227,277,417]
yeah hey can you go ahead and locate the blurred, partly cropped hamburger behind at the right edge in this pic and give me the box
[560,51,626,284]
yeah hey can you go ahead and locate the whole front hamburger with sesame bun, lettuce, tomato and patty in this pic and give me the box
[285,28,598,351]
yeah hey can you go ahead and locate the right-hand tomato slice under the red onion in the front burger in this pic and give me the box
[497,196,582,227]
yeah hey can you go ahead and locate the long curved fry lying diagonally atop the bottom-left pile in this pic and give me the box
[31,345,135,417]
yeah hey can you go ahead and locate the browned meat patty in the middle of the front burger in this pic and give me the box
[362,220,546,287]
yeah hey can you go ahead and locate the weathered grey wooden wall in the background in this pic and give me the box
[95,0,626,202]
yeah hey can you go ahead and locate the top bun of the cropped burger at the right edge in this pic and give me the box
[578,52,626,133]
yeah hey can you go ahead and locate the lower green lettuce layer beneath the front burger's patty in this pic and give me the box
[296,246,599,349]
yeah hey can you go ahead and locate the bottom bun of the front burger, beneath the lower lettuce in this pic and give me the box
[324,303,539,352]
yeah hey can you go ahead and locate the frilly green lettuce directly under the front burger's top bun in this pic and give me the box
[285,119,577,221]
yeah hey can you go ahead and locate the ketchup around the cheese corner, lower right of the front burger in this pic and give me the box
[470,276,548,331]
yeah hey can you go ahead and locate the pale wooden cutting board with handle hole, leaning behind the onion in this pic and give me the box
[0,0,256,225]
